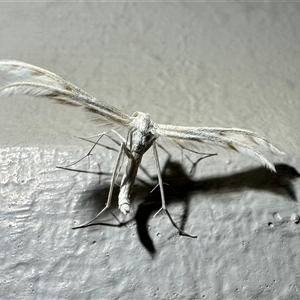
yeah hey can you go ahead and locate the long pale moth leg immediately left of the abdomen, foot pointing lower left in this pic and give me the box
[72,142,127,229]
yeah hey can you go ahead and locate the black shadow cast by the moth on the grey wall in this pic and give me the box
[71,160,300,256]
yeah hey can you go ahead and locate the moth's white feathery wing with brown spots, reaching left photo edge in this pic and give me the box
[0,60,130,127]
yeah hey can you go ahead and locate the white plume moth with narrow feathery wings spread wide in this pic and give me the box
[0,60,283,237]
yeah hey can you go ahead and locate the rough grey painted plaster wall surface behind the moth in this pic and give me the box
[0,2,300,300]
